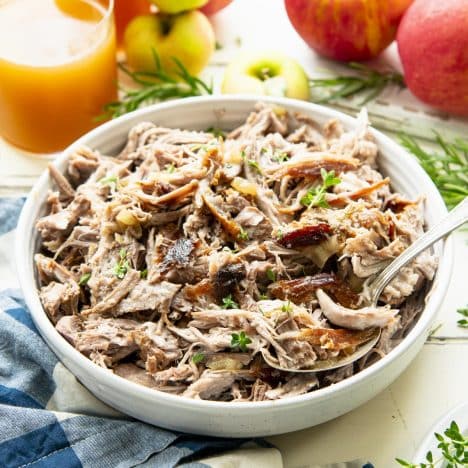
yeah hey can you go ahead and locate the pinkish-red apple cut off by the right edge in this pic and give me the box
[397,0,468,115]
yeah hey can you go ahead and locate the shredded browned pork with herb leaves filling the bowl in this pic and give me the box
[35,104,436,401]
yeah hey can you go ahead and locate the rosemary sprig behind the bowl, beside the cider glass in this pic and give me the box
[101,51,213,119]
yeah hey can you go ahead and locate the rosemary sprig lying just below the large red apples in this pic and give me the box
[309,62,405,105]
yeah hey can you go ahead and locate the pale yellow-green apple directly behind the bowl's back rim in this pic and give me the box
[221,52,310,100]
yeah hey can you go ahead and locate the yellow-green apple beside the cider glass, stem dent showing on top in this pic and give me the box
[124,10,215,75]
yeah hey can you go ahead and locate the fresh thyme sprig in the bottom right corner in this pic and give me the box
[396,421,468,468]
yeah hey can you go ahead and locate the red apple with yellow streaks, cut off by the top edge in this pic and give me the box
[285,0,412,61]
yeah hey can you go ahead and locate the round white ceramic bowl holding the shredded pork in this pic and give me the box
[16,96,452,437]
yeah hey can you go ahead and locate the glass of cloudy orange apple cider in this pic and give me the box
[0,0,117,153]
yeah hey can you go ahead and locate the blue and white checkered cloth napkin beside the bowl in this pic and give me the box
[0,199,282,468]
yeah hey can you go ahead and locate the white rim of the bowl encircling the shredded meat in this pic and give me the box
[15,95,453,412]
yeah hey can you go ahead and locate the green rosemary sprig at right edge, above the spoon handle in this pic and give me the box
[400,132,468,208]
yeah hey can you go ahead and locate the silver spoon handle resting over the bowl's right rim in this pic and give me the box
[368,198,468,305]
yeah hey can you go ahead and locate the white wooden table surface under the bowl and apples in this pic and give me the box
[0,0,468,468]
